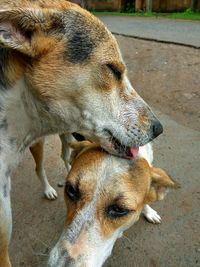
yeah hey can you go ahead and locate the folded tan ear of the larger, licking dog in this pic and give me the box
[0,8,57,57]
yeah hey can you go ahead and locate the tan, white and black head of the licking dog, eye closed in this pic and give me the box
[0,0,162,157]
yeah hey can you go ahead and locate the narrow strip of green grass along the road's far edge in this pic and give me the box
[92,10,200,20]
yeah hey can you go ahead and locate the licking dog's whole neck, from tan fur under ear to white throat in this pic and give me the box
[0,48,79,174]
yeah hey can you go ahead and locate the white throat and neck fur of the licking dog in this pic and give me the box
[0,68,71,175]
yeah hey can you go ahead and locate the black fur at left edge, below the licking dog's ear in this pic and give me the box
[0,48,8,90]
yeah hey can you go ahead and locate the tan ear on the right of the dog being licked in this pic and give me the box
[145,167,179,203]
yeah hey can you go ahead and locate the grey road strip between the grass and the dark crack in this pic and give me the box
[99,15,200,48]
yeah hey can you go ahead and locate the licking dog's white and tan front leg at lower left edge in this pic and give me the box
[0,177,12,267]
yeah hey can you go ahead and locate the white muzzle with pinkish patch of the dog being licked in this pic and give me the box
[47,211,113,267]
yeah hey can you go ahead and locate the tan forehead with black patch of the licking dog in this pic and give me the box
[57,9,121,64]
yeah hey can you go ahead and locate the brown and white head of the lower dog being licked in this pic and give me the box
[48,142,176,267]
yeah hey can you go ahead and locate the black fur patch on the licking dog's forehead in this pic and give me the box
[64,11,105,64]
